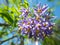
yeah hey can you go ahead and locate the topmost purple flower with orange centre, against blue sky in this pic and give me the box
[34,4,49,16]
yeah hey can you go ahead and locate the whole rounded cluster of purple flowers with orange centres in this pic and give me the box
[18,4,54,39]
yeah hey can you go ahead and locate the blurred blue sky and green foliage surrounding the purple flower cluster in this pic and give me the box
[0,0,60,45]
